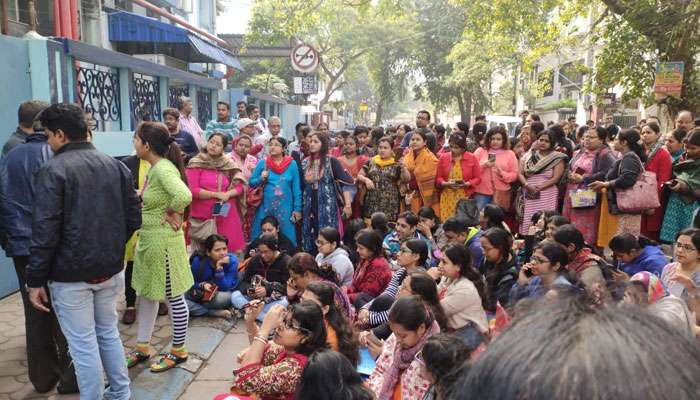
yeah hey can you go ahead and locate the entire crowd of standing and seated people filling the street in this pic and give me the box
[0,98,700,400]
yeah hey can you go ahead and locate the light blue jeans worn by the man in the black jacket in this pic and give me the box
[49,271,131,400]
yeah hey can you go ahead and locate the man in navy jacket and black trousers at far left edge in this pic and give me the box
[0,122,78,393]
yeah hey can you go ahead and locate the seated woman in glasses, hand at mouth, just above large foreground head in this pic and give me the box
[510,240,575,303]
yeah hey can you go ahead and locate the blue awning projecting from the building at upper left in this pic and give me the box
[109,11,243,71]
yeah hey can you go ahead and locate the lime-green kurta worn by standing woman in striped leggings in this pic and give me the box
[131,159,194,301]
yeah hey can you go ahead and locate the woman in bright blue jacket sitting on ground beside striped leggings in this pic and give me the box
[185,235,238,318]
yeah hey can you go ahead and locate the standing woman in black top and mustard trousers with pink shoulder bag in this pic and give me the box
[588,129,646,247]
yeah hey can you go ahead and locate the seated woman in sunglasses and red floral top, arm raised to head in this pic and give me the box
[231,301,326,400]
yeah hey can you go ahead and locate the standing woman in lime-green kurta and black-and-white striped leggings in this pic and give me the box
[126,122,194,372]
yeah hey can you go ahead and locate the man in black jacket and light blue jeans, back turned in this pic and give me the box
[27,104,141,400]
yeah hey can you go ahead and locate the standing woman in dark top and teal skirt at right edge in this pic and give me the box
[661,128,700,243]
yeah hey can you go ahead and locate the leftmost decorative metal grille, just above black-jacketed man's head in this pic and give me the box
[75,62,122,130]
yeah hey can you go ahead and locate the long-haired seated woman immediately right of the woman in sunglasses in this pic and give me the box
[301,282,360,366]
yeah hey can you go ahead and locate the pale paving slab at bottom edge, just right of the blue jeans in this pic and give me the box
[131,368,193,400]
